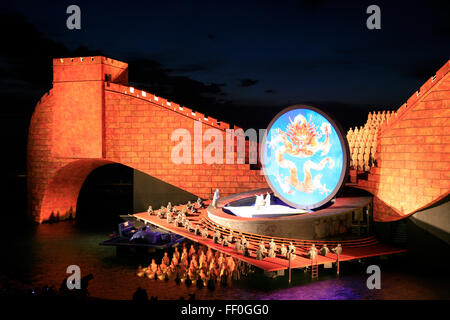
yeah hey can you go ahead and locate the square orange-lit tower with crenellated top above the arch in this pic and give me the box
[51,57,128,158]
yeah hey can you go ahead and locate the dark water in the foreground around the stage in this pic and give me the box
[0,222,450,300]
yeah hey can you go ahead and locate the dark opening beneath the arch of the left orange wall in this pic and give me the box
[66,163,201,226]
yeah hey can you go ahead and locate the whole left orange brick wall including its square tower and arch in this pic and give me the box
[27,57,267,222]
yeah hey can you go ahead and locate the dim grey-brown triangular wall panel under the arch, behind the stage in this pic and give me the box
[133,170,197,212]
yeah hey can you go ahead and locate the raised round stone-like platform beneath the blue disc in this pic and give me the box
[207,188,372,240]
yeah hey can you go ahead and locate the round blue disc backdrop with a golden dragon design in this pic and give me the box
[262,106,348,209]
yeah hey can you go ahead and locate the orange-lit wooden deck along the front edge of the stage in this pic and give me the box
[133,209,407,271]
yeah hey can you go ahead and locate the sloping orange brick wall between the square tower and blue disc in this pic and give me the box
[105,84,266,198]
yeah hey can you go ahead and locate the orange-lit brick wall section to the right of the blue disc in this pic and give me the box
[358,61,450,221]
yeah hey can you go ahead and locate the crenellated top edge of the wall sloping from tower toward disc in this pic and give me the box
[104,83,232,131]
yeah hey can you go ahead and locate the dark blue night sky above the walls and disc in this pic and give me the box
[0,0,450,175]
